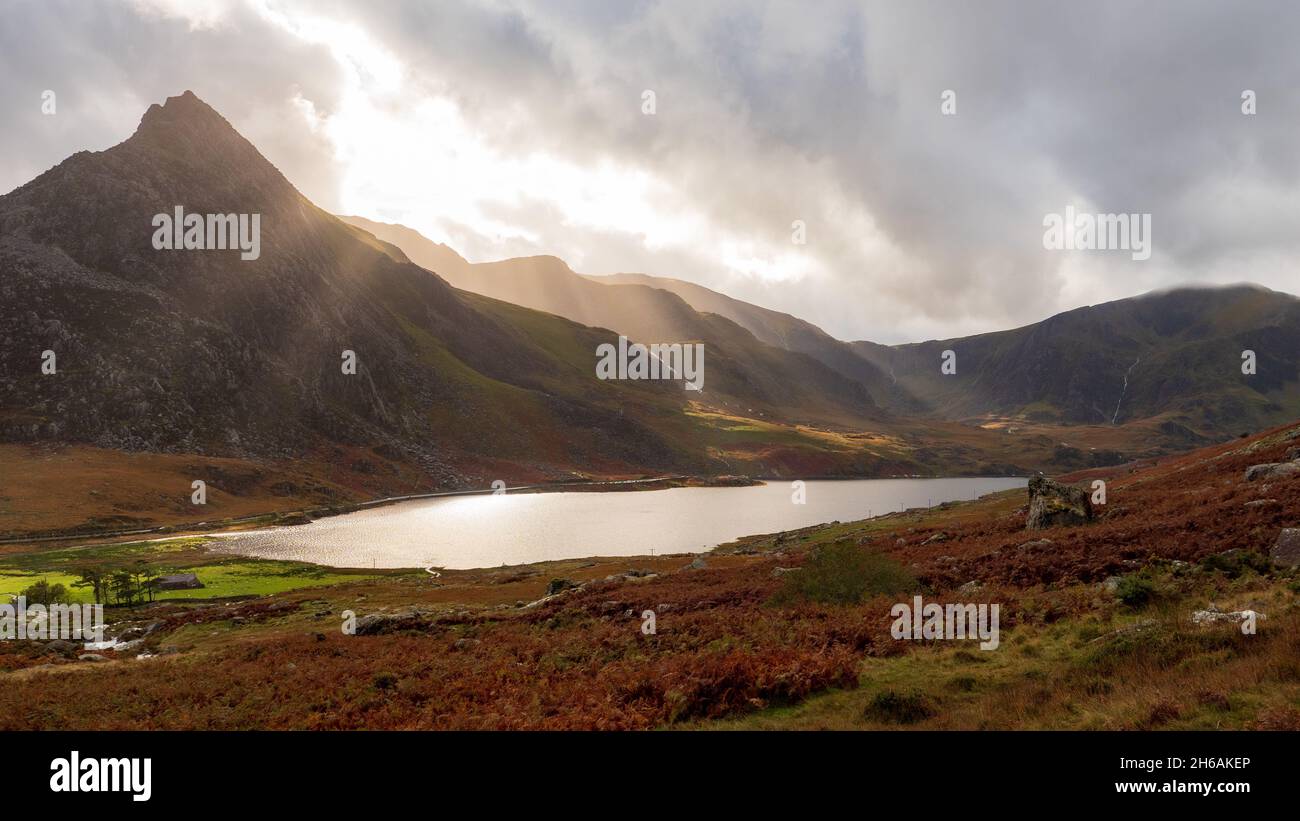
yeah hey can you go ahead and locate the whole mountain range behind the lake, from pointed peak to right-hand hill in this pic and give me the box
[0,92,1300,539]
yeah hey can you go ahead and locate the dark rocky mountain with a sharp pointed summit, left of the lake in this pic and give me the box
[0,92,759,485]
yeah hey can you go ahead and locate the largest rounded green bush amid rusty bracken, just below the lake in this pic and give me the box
[772,540,918,604]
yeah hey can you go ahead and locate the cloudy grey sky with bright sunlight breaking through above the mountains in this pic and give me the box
[0,0,1300,343]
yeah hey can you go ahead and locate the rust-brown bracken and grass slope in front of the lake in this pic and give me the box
[0,429,1300,729]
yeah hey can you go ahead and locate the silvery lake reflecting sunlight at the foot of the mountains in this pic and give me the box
[212,478,1027,569]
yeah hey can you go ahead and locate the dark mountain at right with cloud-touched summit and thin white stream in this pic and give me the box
[854,286,1300,440]
